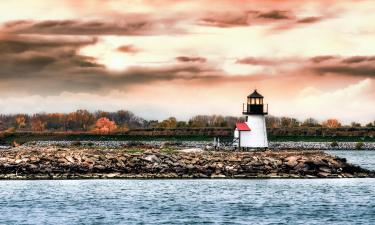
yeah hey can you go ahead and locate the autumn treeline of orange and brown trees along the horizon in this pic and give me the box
[0,110,375,133]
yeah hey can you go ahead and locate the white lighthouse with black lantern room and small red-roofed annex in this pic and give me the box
[233,90,268,148]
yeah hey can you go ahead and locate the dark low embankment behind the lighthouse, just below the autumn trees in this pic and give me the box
[0,127,375,145]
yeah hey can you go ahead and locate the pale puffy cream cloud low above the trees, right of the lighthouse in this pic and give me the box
[294,78,375,124]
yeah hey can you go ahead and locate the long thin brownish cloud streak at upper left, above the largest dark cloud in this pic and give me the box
[3,14,183,35]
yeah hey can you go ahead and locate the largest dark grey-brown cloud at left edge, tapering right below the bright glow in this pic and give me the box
[0,36,223,94]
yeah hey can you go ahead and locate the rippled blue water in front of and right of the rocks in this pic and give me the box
[0,151,375,225]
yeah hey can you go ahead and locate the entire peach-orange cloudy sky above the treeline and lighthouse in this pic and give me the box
[0,0,375,124]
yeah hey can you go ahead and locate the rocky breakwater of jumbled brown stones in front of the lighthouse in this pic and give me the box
[0,146,375,179]
